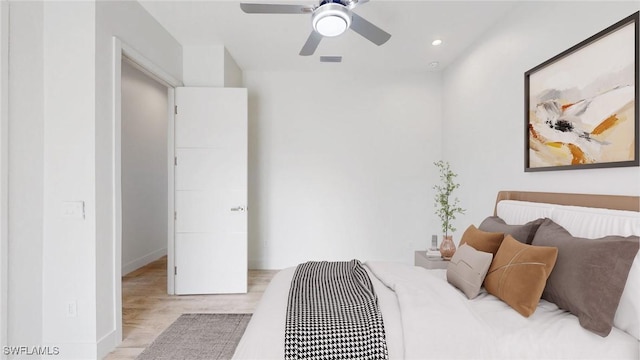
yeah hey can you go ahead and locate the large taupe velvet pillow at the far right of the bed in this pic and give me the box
[533,219,639,337]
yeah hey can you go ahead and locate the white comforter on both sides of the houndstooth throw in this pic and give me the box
[234,262,640,359]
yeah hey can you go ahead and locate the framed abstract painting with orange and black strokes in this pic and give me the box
[525,12,640,172]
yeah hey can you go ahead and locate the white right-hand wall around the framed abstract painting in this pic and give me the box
[443,2,640,236]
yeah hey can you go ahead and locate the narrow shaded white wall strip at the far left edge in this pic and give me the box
[7,2,44,345]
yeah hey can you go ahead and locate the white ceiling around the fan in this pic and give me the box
[140,0,517,71]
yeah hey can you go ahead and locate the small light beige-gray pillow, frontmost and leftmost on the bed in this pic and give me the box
[447,244,493,299]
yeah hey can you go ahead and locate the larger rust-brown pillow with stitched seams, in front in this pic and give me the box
[484,235,558,317]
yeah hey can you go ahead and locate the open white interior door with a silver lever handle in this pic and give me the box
[175,87,247,295]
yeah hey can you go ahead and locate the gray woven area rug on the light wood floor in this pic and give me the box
[136,314,251,360]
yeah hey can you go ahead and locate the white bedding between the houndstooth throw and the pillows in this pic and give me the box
[367,263,640,359]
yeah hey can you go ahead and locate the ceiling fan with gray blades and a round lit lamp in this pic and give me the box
[240,0,391,56]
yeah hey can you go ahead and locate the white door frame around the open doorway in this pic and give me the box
[111,36,183,343]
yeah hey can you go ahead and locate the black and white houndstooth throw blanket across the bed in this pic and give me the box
[284,260,389,360]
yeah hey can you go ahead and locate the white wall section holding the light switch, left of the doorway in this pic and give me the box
[42,2,97,358]
